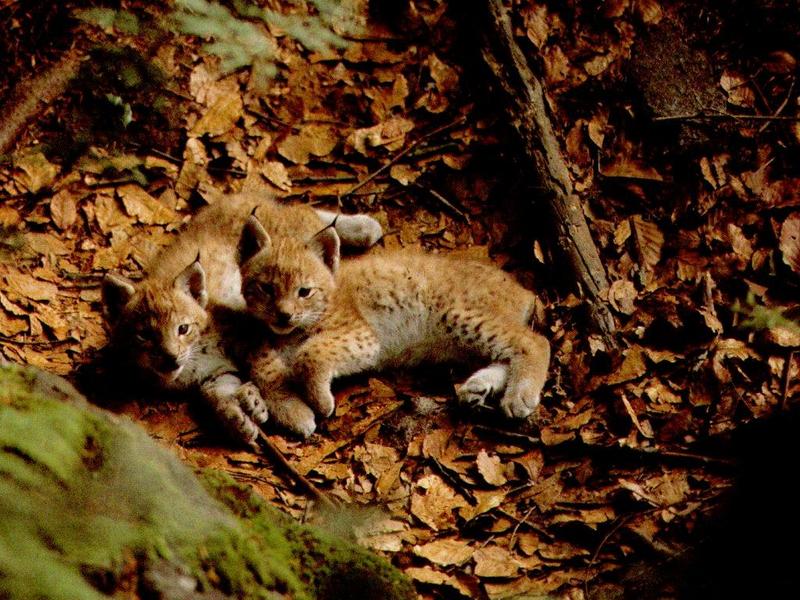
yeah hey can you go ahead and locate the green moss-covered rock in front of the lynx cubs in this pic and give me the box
[0,366,414,600]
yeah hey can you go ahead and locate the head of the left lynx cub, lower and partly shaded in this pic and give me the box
[103,260,208,382]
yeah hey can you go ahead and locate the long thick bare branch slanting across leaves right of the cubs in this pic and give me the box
[478,0,616,347]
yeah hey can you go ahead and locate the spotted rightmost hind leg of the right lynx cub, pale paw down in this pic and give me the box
[500,330,550,419]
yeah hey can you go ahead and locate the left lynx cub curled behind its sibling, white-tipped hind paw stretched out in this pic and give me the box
[103,194,382,442]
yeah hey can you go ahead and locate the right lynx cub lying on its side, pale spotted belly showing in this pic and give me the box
[241,217,550,435]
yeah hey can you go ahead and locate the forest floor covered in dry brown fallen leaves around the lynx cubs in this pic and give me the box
[0,0,800,599]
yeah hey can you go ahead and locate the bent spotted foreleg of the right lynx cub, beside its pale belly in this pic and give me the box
[294,321,381,417]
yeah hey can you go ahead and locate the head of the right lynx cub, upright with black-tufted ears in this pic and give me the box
[239,216,339,335]
